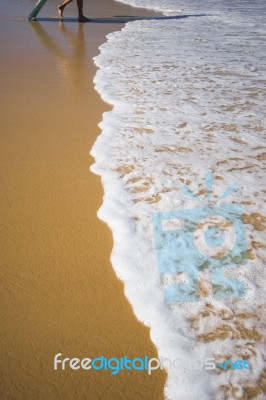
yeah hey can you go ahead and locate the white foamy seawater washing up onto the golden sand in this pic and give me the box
[91,0,266,400]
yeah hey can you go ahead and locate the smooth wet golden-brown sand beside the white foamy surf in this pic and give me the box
[0,0,166,400]
